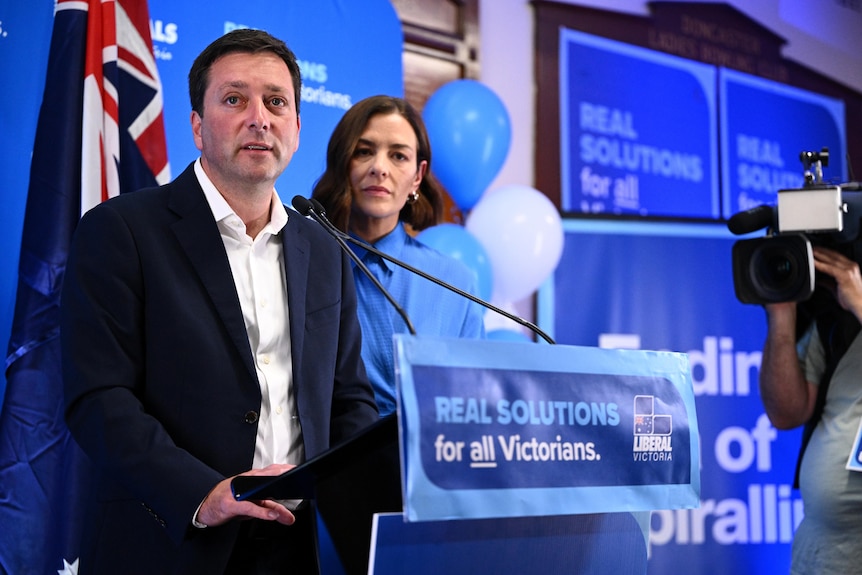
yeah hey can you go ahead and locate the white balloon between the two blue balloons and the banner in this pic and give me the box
[465,185,563,301]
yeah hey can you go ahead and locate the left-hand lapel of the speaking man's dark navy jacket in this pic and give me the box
[169,166,257,379]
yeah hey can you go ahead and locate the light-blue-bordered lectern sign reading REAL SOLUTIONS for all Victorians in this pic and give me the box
[396,336,700,521]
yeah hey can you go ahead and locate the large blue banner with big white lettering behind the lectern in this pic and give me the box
[537,220,802,575]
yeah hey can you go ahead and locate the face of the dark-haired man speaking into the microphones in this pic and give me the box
[192,52,300,194]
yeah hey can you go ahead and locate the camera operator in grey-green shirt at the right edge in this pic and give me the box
[760,248,862,575]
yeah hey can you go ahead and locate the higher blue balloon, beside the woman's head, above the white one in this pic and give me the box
[422,80,512,211]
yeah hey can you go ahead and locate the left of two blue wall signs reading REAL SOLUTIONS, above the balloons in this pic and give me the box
[560,29,719,218]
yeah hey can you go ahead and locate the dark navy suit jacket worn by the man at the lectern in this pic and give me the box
[61,166,378,574]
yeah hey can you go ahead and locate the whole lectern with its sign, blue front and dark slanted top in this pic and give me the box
[233,335,700,575]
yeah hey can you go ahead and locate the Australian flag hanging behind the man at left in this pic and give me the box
[0,0,170,575]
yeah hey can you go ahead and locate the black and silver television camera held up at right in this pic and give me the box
[727,148,862,305]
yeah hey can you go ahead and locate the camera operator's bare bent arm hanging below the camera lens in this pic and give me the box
[760,303,817,429]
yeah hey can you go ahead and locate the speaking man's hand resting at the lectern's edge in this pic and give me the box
[197,464,296,527]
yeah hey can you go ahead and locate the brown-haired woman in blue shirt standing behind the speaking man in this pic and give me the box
[312,96,484,416]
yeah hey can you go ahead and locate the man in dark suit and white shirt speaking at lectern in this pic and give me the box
[61,30,378,574]
